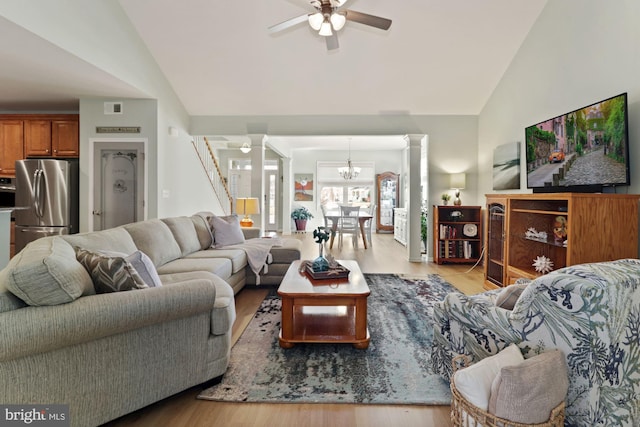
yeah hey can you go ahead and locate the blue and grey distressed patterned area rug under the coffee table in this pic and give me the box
[198,274,458,405]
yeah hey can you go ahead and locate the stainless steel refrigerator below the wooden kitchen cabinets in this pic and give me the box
[15,159,79,253]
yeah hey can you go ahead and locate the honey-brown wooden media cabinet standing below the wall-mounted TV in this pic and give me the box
[484,193,640,289]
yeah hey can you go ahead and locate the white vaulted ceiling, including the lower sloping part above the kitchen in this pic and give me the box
[0,0,546,116]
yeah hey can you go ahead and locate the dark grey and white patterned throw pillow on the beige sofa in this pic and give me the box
[76,248,149,294]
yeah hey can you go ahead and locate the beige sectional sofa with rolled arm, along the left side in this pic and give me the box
[0,215,300,426]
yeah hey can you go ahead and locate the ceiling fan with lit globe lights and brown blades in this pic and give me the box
[269,0,391,50]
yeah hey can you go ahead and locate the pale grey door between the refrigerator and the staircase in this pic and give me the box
[93,142,145,231]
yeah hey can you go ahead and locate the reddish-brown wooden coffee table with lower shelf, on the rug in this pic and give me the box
[278,260,370,349]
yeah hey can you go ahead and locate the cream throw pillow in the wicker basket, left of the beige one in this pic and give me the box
[453,344,524,411]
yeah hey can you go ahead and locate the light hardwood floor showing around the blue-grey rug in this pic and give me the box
[105,232,483,427]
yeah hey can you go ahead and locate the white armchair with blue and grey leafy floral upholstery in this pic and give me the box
[432,259,640,426]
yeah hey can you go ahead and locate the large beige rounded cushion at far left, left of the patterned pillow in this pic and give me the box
[6,236,95,306]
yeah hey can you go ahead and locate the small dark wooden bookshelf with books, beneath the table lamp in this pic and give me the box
[433,205,482,264]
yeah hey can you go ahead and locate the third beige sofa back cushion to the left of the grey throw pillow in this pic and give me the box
[123,219,182,267]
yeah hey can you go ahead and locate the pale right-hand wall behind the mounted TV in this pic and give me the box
[477,0,640,200]
